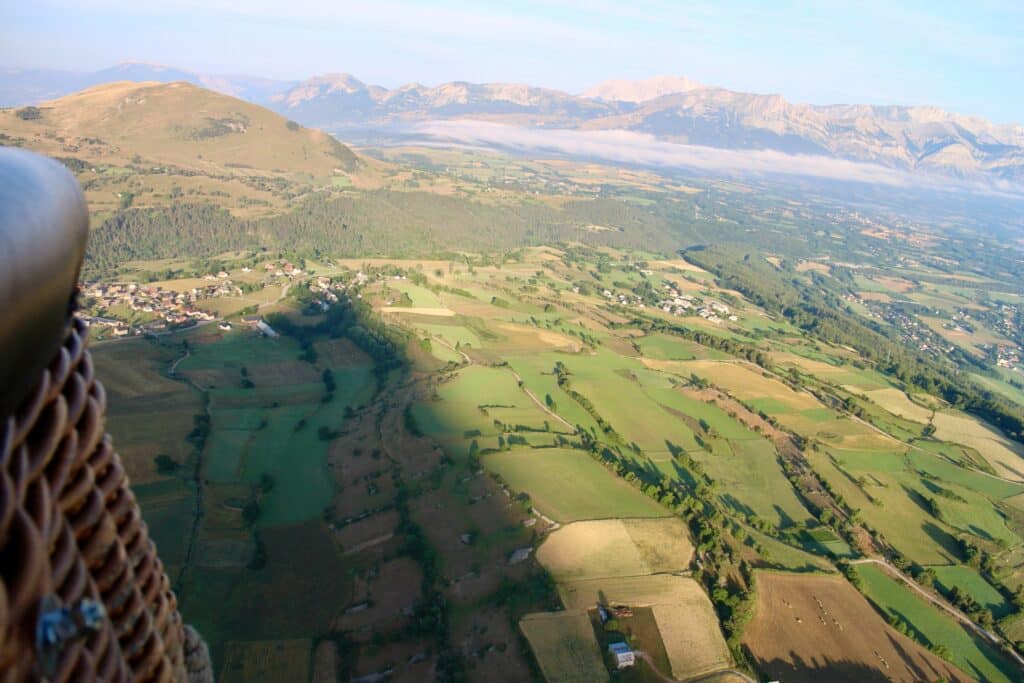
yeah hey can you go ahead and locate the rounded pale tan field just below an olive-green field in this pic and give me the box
[537,517,693,582]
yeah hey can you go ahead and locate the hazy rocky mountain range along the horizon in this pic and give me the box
[0,62,1024,182]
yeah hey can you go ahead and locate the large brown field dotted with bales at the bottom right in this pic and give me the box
[743,572,971,683]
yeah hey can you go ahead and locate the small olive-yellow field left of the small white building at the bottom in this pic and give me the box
[519,611,608,683]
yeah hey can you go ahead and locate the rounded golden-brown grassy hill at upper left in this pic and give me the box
[0,81,368,216]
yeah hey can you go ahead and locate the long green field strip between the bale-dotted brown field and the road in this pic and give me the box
[857,565,1017,681]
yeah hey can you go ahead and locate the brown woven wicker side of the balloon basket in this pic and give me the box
[0,321,191,682]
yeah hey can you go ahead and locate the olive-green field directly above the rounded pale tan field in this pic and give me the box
[483,449,669,522]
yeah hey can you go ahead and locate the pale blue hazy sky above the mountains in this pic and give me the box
[0,0,1024,123]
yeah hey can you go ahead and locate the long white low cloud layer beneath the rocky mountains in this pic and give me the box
[403,120,1024,198]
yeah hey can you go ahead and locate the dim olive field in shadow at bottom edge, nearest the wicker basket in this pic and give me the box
[217,639,310,683]
